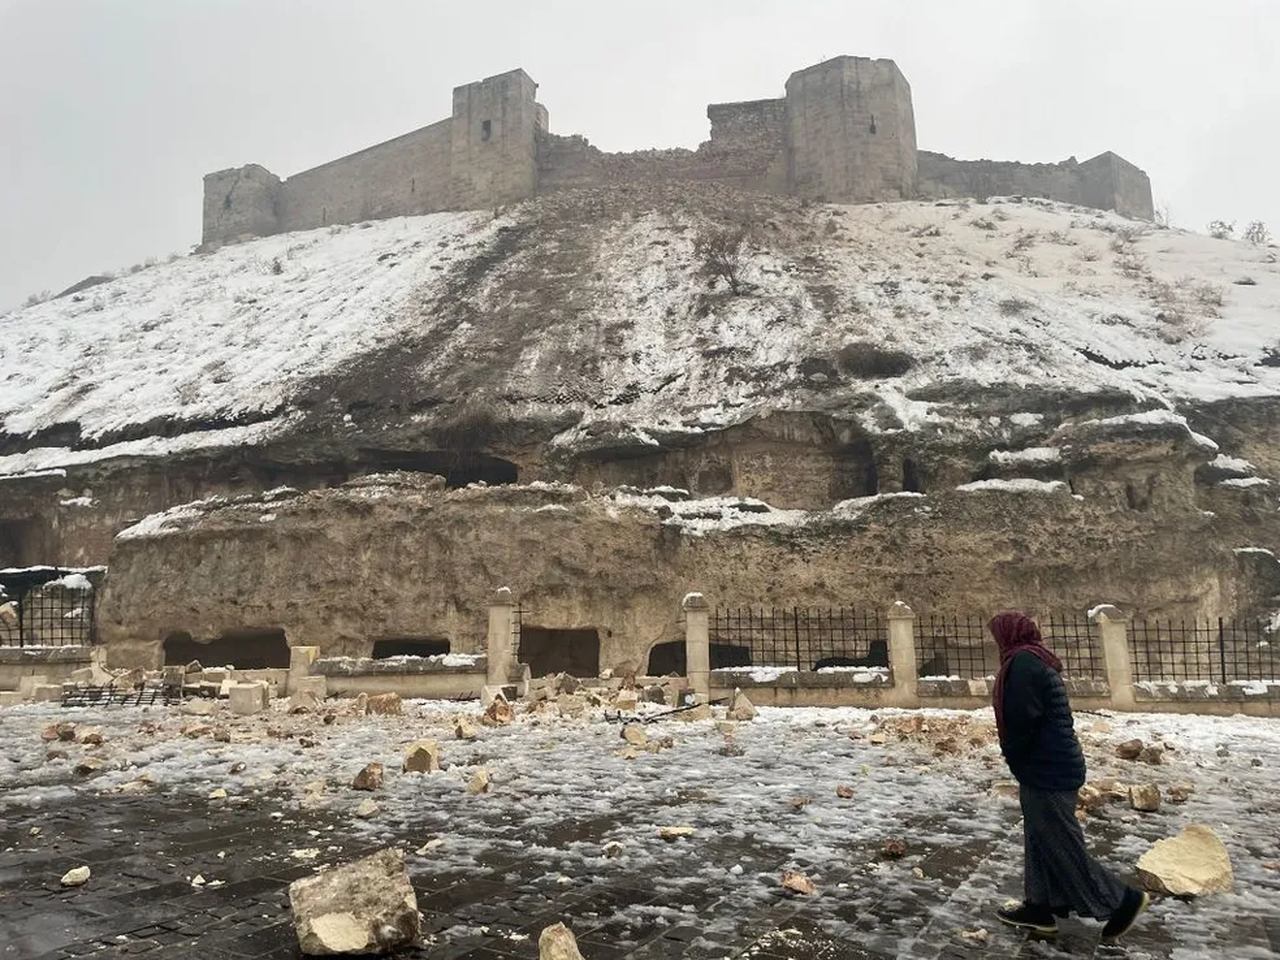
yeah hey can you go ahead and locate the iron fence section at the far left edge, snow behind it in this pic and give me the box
[0,567,97,646]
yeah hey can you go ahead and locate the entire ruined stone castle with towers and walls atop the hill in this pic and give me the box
[202,56,1153,246]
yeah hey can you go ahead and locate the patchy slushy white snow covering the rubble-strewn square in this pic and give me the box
[0,701,1280,960]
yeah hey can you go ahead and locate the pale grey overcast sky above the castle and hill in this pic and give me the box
[0,0,1280,310]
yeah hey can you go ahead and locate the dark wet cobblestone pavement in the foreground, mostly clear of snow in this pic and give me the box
[0,701,1280,960]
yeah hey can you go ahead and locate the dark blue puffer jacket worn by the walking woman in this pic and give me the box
[1000,653,1084,791]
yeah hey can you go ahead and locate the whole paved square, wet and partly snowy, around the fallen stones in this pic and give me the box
[0,710,1280,960]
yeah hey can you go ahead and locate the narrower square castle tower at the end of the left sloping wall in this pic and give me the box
[449,70,547,210]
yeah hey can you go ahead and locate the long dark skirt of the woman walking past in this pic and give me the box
[1019,786,1125,920]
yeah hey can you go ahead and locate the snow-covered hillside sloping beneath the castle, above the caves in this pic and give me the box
[0,187,1280,474]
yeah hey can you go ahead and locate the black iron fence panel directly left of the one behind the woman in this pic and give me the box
[709,607,888,671]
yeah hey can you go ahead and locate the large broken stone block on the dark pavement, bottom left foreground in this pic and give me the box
[289,850,421,956]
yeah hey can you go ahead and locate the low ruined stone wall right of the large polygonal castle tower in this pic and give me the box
[919,150,1153,220]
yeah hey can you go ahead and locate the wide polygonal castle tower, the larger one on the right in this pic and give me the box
[786,56,916,204]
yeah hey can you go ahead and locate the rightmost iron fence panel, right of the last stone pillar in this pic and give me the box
[1129,617,1280,684]
